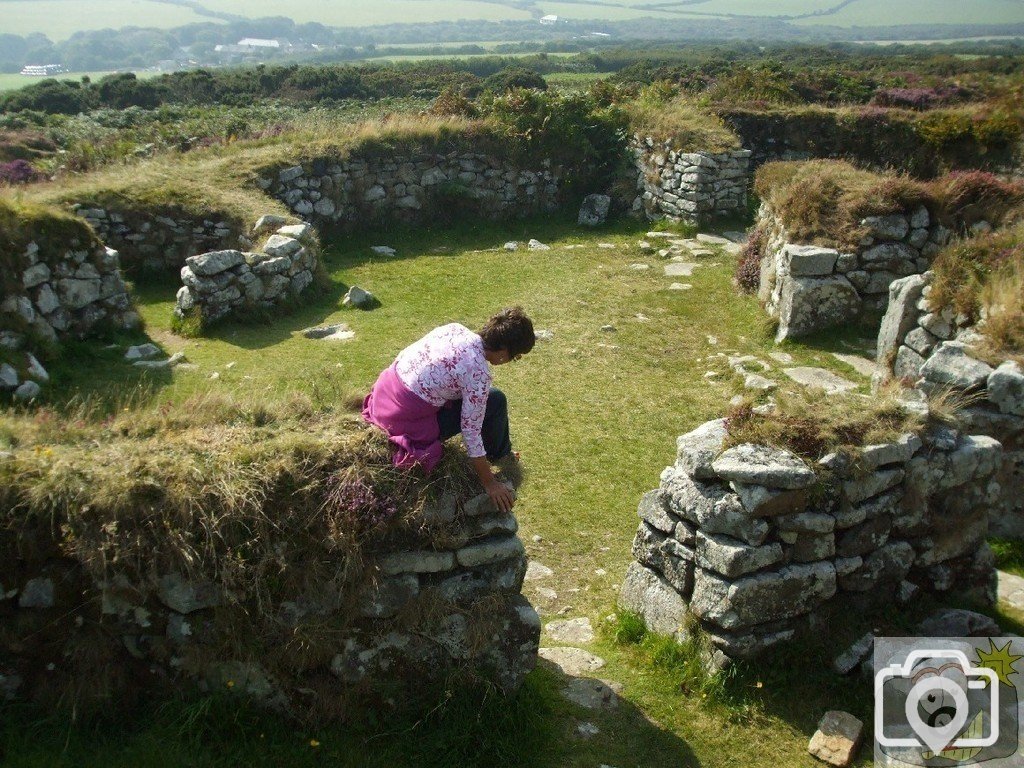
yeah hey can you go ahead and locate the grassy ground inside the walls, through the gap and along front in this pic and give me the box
[14,214,1015,768]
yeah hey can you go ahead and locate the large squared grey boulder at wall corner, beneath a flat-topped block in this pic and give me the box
[775,275,860,342]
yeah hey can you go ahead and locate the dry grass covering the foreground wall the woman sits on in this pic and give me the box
[0,395,469,607]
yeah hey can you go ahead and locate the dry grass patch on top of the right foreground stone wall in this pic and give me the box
[726,387,920,463]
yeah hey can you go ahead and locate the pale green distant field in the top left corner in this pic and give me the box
[0,0,214,41]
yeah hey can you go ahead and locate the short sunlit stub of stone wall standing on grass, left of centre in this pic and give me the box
[174,222,319,323]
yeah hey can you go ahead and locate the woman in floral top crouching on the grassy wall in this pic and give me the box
[362,307,536,512]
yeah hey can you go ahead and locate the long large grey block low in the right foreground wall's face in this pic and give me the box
[690,561,836,630]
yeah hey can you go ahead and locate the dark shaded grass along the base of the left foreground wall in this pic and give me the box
[0,670,696,768]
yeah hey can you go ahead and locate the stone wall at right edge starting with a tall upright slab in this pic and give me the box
[878,272,1024,539]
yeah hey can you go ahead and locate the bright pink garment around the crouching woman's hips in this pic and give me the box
[362,364,441,472]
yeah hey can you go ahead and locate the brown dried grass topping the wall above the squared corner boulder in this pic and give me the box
[754,160,938,249]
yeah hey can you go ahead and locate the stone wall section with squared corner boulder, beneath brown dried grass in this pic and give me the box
[758,204,950,341]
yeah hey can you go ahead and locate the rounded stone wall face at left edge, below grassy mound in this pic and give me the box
[0,239,139,350]
